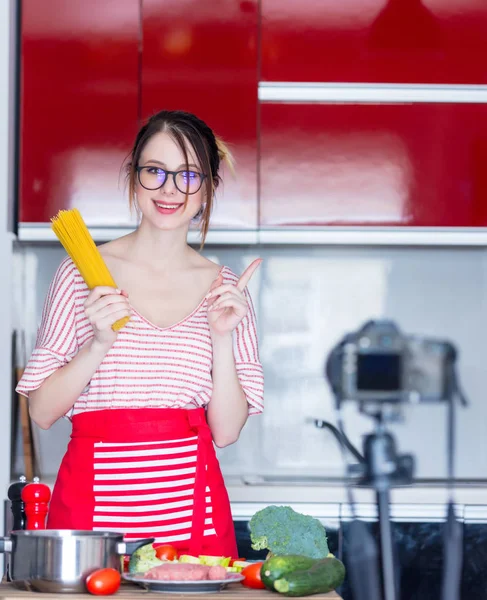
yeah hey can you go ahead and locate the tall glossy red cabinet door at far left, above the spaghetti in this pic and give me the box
[19,0,140,225]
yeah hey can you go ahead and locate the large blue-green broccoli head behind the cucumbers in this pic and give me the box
[249,506,329,558]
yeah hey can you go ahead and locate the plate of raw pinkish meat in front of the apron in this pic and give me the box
[123,563,244,594]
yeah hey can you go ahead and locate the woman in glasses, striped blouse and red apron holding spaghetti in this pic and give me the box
[17,111,263,557]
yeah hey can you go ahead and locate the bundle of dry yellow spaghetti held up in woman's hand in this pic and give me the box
[51,208,129,331]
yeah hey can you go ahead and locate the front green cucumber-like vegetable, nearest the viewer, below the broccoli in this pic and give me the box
[274,557,345,596]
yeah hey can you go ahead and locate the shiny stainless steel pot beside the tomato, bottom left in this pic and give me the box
[0,529,154,593]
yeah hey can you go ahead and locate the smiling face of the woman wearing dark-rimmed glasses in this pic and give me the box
[135,132,205,229]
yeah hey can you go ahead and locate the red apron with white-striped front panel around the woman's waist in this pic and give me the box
[47,408,237,558]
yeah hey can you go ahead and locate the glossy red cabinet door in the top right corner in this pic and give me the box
[262,0,487,84]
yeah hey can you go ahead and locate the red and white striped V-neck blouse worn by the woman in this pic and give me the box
[17,258,264,417]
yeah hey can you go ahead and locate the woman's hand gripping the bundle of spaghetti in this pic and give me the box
[84,285,131,350]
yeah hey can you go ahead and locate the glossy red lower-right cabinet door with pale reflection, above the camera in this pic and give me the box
[260,104,487,227]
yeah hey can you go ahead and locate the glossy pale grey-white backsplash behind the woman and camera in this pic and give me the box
[14,241,487,478]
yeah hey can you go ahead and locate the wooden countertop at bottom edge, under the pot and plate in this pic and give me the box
[0,583,341,600]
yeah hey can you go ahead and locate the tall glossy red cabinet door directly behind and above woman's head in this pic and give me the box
[141,0,258,229]
